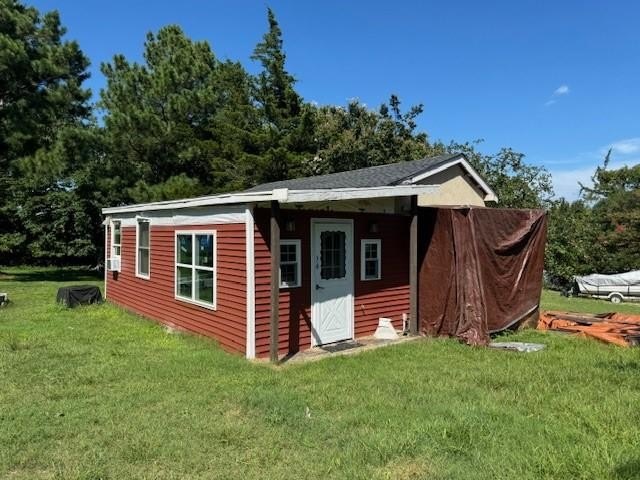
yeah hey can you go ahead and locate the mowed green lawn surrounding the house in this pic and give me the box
[0,269,640,480]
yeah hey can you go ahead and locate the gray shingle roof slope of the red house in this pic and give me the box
[246,154,460,192]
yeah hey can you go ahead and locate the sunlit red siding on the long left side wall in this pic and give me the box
[107,223,247,353]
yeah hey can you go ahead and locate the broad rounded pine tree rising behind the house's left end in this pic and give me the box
[100,25,257,202]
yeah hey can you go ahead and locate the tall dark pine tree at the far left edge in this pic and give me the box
[0,0,94,263]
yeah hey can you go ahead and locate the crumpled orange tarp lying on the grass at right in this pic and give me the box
[538,312,640,347]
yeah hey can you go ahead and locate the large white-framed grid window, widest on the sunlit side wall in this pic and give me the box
[176,231,216,309]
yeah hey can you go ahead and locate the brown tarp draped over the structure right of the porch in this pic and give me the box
[418,207,546,345]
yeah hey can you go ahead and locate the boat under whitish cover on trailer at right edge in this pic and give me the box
[573,270,640,303]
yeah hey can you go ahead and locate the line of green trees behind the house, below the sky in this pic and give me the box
[0,0,640,284]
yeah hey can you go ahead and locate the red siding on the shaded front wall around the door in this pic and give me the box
[255,209,410,357]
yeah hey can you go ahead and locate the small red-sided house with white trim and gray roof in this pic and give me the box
[103,155,495,359]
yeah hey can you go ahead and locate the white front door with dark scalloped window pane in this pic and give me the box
[311,219,353,345]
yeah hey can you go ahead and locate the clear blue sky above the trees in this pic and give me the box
[28,0,640,198]
